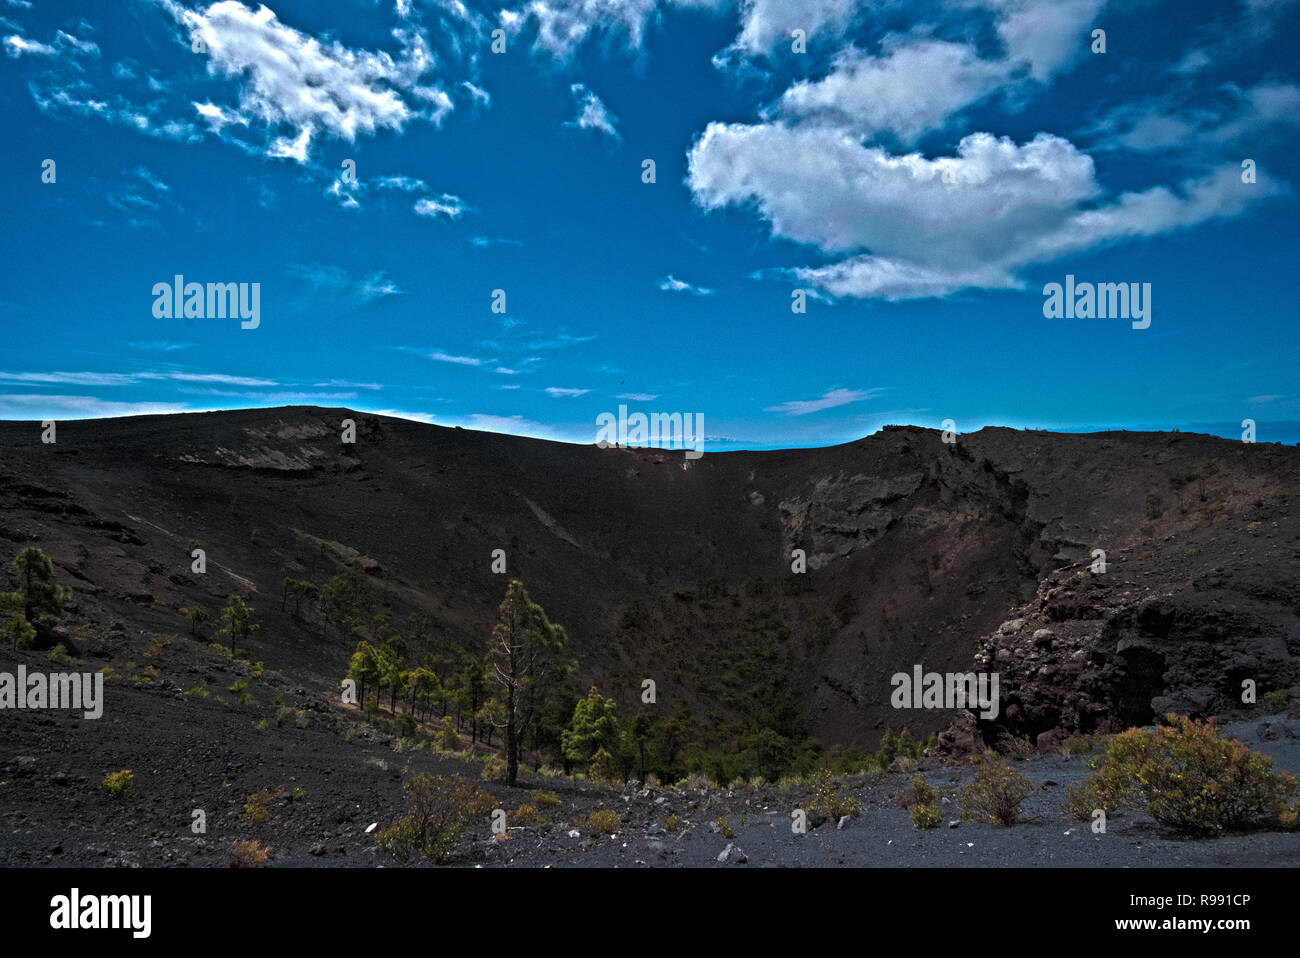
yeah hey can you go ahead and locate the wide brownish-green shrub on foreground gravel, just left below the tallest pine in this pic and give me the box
[374,773,497,862]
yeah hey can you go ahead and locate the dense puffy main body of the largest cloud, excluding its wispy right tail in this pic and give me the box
[688,123,1099,264]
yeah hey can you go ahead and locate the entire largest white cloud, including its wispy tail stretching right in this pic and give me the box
[688,123,1279,299]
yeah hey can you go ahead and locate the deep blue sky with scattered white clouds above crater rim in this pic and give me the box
[0,0,1300,448]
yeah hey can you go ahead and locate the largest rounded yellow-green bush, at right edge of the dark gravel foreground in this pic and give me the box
[1067,714,1300,835]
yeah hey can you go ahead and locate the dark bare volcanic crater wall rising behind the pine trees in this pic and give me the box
[0,407,1300,746]
